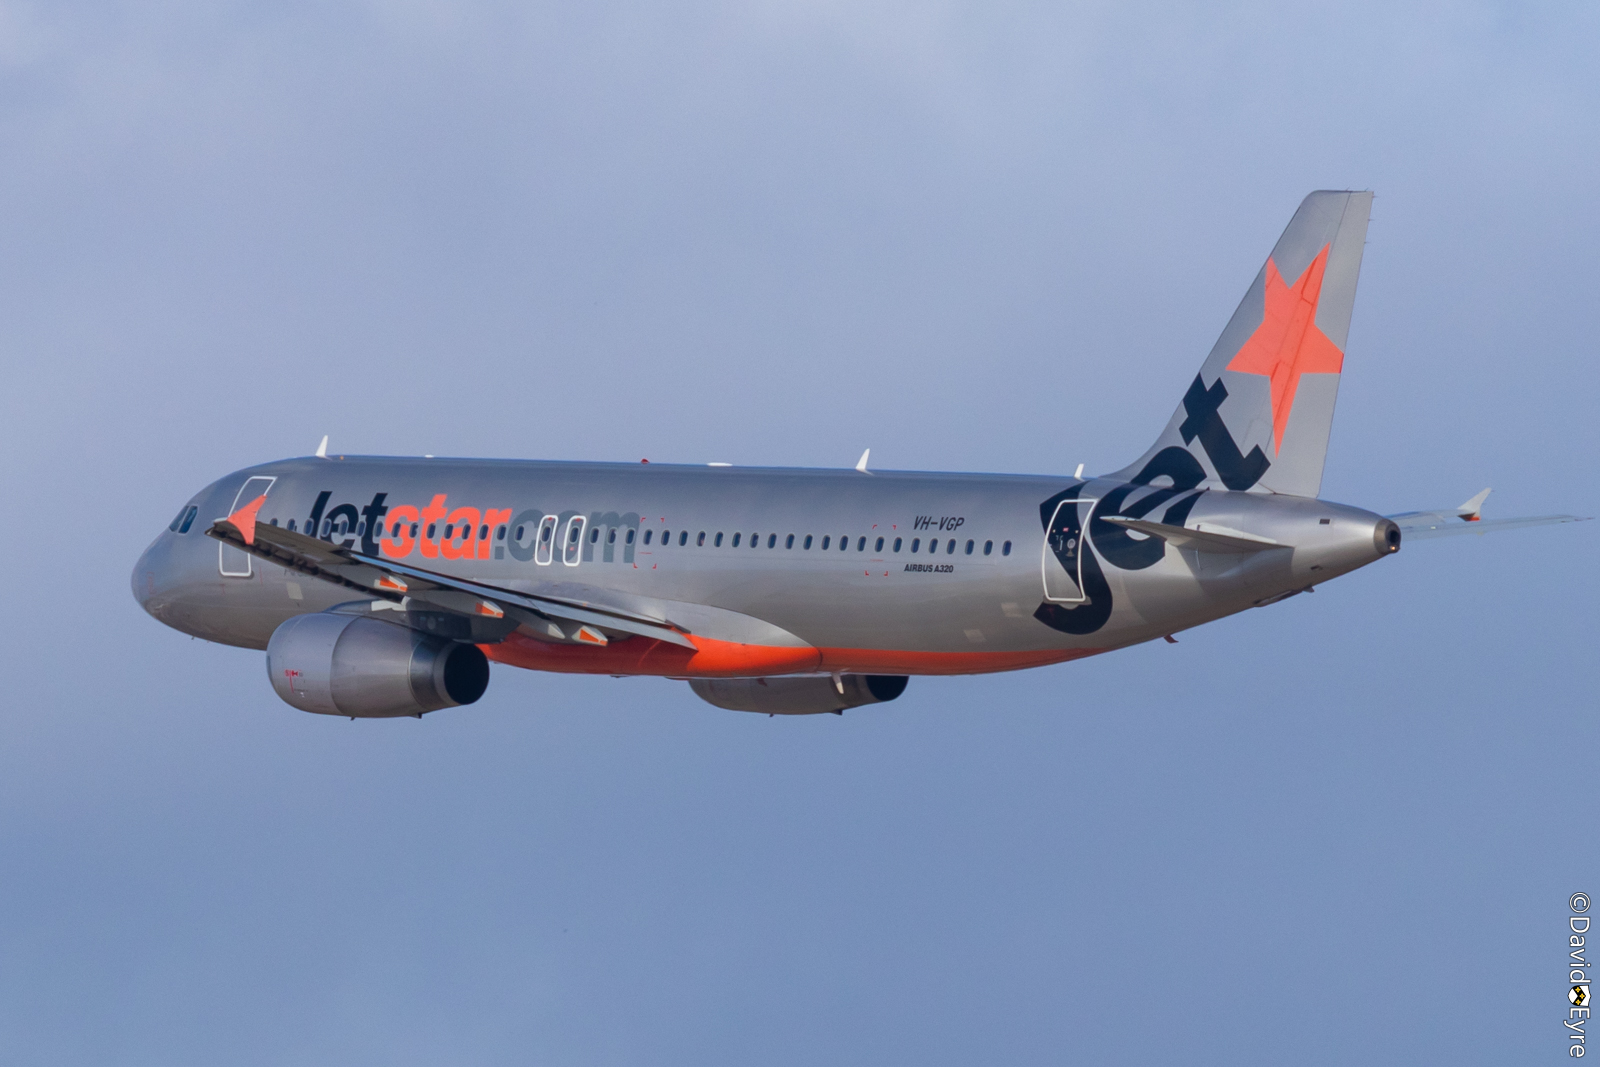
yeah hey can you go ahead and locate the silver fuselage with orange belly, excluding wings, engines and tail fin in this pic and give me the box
[133,458,1392,677]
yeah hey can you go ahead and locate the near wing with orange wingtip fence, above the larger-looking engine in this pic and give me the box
[206,494,694,648]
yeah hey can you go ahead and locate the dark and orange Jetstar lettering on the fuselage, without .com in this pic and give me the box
[306,490,510,560]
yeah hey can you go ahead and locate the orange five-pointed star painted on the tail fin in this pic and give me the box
[1227,245,1344,451]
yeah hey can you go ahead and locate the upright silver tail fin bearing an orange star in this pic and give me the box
[1118,190,1373,496]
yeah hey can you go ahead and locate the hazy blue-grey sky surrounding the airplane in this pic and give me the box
[0,0,1600,1067]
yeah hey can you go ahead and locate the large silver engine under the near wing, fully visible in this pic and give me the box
[267,611,490,718]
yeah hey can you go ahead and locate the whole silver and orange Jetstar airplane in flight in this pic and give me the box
[131,190,1578,718]
